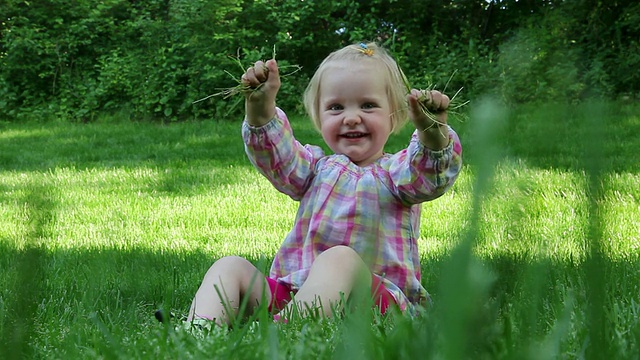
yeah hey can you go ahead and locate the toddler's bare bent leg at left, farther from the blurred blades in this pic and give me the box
[187,256,271,325]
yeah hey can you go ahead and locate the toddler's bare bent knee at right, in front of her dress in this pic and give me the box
[282,246,372,317]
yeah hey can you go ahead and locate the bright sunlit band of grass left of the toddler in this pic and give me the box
[0,167,296,256]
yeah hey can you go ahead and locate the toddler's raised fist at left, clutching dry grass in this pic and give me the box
[241,59,280,126]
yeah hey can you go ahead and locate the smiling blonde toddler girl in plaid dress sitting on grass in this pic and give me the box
[188,43,462,324]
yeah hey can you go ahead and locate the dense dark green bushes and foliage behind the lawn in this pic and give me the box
[0,0,640,121]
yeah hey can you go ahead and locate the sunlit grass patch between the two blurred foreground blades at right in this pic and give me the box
[479,162,587,260]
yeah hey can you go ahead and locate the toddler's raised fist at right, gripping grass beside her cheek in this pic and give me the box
[407,89,450,150]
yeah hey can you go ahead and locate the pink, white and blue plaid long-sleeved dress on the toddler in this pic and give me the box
[242,109,462,310]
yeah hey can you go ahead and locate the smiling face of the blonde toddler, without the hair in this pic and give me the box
[318,61,391,166]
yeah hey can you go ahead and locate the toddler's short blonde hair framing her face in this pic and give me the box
[304,43,408,132]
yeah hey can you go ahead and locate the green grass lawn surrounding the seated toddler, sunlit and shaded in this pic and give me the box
[0,104,640,359]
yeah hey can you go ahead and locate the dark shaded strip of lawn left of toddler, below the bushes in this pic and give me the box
[0,121,250,171]
